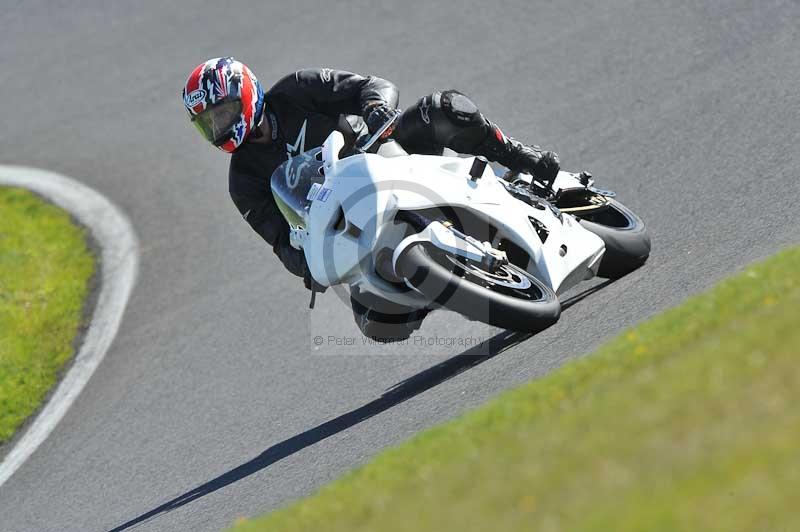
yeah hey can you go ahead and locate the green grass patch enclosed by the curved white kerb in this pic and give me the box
[0,188,94,444]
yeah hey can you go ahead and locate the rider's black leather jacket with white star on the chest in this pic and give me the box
[228,68,399,278]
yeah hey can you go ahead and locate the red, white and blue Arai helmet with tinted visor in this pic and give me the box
[183,57,264,153]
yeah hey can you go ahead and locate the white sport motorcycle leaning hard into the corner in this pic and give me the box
[271,114,650,332]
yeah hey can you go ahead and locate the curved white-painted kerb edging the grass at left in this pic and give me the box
[0,165,139,486]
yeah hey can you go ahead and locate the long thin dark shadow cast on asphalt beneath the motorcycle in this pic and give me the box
[109,281,611,532]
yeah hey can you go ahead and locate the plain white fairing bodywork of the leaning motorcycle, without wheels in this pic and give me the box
[300,132,604,306]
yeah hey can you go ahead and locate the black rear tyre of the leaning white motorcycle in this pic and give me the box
[580,200,650,279]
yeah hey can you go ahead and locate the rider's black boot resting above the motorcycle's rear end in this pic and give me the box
[473,120,560,187]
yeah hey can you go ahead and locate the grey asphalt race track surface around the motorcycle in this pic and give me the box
[0,0,800,531]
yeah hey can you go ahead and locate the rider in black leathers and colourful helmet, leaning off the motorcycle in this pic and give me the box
[183,57,559,341]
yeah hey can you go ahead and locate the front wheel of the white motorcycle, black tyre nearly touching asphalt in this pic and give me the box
[395,242,561,332]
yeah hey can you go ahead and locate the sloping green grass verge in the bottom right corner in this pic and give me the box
[236,249,800,532]
